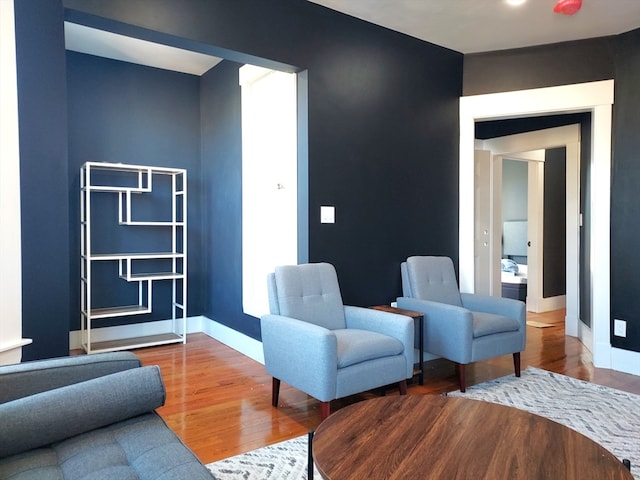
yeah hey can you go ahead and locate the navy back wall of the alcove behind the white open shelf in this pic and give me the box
[67,52,203,330]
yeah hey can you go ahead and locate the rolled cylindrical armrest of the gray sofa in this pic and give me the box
[0,366,165,458]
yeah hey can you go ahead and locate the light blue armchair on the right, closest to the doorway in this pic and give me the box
[398,257,527,392]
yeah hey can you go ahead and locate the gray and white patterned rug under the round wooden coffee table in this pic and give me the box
[207,367,640,480]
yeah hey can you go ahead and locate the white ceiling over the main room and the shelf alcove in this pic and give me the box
[65,0,640,75]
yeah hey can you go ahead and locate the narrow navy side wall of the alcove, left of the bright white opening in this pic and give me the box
[201,61,260,338]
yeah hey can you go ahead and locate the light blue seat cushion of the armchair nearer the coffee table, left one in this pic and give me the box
[333,328,404,368]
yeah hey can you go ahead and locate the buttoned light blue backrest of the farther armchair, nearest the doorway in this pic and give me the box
[400,256,462,307]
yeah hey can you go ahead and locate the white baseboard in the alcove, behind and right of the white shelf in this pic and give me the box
[69,315,264,365]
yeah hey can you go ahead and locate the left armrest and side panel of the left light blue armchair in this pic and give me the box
[260,315,338,401]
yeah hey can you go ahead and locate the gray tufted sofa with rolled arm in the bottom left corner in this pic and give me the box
[0,352,213,480]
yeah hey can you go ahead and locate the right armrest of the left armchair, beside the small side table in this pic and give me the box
[344,306,415,378]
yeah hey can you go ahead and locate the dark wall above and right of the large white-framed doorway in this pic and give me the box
[463,29,640,351]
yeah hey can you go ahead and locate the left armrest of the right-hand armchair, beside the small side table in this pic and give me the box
[397,297,473,363]
